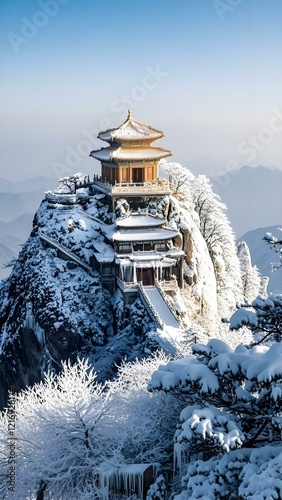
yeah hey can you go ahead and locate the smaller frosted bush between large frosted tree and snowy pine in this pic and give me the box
[108,353,181,467]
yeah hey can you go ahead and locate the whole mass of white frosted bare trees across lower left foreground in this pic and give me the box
[0,354,183,500]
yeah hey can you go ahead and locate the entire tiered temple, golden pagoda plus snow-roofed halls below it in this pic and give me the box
[91,110,184,303]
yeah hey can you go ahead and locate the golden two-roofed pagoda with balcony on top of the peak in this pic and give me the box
[90,109,172,207]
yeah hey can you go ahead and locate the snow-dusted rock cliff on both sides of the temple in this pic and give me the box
[0,182,220,407]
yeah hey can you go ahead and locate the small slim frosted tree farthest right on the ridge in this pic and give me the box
[237,241,261,302]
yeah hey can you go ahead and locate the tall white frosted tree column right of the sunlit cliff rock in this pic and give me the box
[192,175,242,316]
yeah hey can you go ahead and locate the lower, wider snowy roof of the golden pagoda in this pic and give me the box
[90,146,172,161]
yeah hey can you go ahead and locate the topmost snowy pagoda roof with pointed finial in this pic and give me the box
[98,109,164,142]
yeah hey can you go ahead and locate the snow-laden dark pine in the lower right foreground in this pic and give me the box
[150,340,282,500]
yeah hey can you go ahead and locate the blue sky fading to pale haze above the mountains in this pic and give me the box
[0,0,282,180]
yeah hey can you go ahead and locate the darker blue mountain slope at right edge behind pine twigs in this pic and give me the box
[238,225,282,293]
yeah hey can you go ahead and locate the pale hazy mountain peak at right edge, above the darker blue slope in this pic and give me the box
[212,165,282,239]
